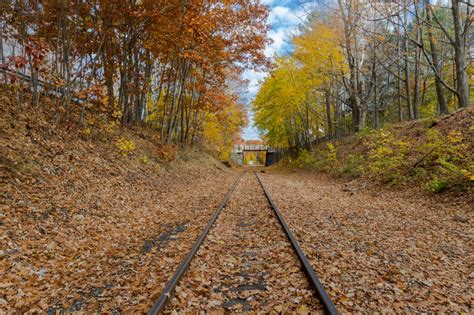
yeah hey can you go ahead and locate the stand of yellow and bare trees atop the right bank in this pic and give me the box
[253,0,472,148]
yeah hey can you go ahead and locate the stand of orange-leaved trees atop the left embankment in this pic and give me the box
[0,0,268,149]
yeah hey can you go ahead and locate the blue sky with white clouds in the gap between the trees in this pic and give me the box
[241,0,307,140]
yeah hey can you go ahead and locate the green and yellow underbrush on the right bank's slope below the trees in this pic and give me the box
[293,111,474,193]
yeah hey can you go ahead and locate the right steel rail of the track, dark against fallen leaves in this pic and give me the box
[254,172,338,315]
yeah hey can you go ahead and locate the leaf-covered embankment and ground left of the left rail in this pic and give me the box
[0,95,237,312]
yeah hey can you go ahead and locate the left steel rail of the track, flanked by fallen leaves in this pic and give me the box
[148,173,244,315]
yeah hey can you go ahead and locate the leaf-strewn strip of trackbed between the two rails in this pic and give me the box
[166,173,321,313]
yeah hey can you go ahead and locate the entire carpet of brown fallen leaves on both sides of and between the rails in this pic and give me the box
[0,92,474,313]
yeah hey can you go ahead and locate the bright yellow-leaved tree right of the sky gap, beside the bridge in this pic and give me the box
[252,22,346,147]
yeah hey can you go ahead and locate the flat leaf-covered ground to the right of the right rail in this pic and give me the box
[262,172,474,313]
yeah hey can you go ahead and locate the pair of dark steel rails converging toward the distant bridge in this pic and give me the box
[149,172,338,315]
